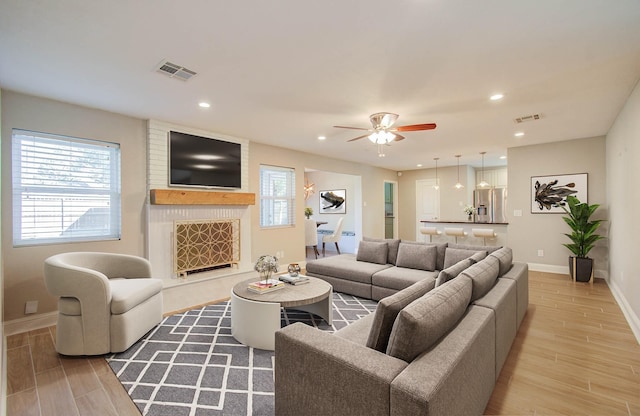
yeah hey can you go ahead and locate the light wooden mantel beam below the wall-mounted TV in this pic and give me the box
[150,189,256,205]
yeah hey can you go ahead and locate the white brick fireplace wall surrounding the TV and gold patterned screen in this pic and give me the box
[146,120,252,281]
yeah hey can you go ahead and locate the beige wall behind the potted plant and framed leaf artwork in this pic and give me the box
[507,137,609,277]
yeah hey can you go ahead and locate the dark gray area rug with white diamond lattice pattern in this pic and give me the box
[107,293,377,416]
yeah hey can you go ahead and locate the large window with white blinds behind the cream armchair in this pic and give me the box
[12,129,120,246]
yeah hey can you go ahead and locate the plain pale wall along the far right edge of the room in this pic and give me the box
[606,79,640,340]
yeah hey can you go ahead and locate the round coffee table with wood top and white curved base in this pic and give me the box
[231,276,333,351]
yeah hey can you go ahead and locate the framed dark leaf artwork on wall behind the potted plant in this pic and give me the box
[531,173,588,214]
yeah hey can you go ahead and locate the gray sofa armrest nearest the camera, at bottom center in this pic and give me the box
[275,323,407,415]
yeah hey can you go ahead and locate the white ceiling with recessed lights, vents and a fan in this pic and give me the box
[0,0,640,171]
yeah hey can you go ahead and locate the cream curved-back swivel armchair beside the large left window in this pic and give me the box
[44,252,162,355]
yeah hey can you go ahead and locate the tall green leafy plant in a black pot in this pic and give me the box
[562,195,604,282]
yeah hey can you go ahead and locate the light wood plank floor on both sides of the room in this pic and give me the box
[7,272,640,416]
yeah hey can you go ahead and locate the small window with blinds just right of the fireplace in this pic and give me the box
[260,165,296,228]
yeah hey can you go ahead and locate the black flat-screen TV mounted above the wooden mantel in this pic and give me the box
[169,131,242,188]
